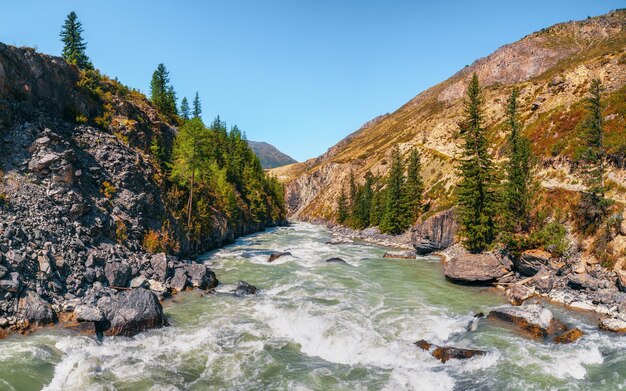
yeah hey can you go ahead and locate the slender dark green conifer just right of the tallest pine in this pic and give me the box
[504,88,535,233]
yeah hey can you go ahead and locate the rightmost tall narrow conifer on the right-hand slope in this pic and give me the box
[577,79,612,234]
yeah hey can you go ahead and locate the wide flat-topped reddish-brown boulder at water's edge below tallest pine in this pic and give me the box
[443,253,509,284]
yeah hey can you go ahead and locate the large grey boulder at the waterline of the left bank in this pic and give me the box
[98,288,167,337]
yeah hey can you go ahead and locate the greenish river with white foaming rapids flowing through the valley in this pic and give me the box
[0,223,626,391]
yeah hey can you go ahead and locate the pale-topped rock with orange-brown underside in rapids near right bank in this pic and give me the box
[487,304,556,338]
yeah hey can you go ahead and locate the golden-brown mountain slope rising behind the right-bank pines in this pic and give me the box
[272,10,626,221]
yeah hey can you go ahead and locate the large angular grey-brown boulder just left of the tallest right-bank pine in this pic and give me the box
[411,209,458,255]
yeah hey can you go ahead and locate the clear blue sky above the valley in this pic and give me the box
[0,0,626,160]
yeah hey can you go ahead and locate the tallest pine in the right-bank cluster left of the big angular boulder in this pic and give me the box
[380,146,406,235]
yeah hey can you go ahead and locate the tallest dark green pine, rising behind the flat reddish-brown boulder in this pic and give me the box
[458,74,497,252]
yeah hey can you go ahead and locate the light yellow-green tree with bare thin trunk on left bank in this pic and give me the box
[171,118,209,227]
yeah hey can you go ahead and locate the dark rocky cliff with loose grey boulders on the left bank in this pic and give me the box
[0,44,271,335]
